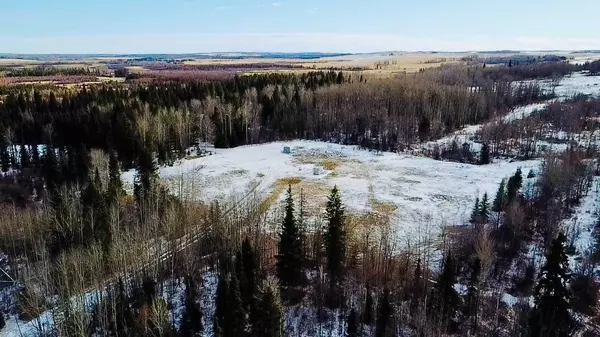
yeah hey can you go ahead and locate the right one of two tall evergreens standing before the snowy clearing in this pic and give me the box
[324,186,346,287]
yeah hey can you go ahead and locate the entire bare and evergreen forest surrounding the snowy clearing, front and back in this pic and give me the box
[0,63,600,337]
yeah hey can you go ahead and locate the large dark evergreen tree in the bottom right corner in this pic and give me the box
[529,233,575,337]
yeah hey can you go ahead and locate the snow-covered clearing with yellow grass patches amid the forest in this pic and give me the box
[123,140,540,242]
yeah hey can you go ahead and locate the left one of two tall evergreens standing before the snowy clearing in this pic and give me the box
[277,186,303,287]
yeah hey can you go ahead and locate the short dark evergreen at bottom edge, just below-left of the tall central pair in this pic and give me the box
[251,287,283,337]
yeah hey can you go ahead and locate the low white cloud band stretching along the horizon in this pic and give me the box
[0,33,600,54]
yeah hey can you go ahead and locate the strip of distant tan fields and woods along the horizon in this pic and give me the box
[0,51,600,79]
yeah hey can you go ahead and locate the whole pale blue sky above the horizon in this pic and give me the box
[0,0,600,53]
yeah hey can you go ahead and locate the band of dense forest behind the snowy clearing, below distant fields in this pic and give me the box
[0,64,564,171]
